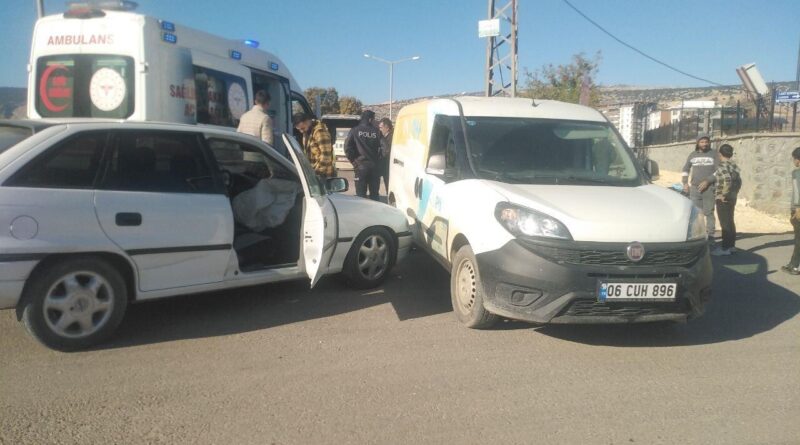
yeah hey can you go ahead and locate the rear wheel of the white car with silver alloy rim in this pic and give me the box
[22,257,128,351]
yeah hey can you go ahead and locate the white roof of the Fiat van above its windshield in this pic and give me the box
[410,96,606,122]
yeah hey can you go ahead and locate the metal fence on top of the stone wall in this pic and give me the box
[643,105,800,146]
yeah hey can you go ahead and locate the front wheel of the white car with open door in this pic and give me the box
[342,227,397,289]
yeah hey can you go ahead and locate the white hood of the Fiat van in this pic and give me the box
[487,181,692,242]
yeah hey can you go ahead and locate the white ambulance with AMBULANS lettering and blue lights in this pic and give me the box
[27,0,311,137]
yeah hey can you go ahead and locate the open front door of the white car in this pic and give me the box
[283,134,339,287]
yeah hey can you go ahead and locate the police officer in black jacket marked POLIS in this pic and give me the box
[344,110,381,201]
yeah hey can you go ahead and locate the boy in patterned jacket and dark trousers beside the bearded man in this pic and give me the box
[701,144,742,256]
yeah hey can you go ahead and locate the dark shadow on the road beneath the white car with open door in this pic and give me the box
[94,251,452,350]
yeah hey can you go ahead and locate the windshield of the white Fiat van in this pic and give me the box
[466,117,644,186]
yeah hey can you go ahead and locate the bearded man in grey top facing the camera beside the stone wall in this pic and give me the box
[681,135,717,241]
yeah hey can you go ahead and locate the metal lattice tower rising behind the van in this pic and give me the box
[478,0,518,97]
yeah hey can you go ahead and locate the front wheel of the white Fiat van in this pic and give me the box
[450,245,498,329]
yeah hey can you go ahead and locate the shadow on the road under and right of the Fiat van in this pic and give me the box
[537,241,800,347]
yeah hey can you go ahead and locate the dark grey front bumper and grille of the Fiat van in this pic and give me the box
[476,240,712,324]
